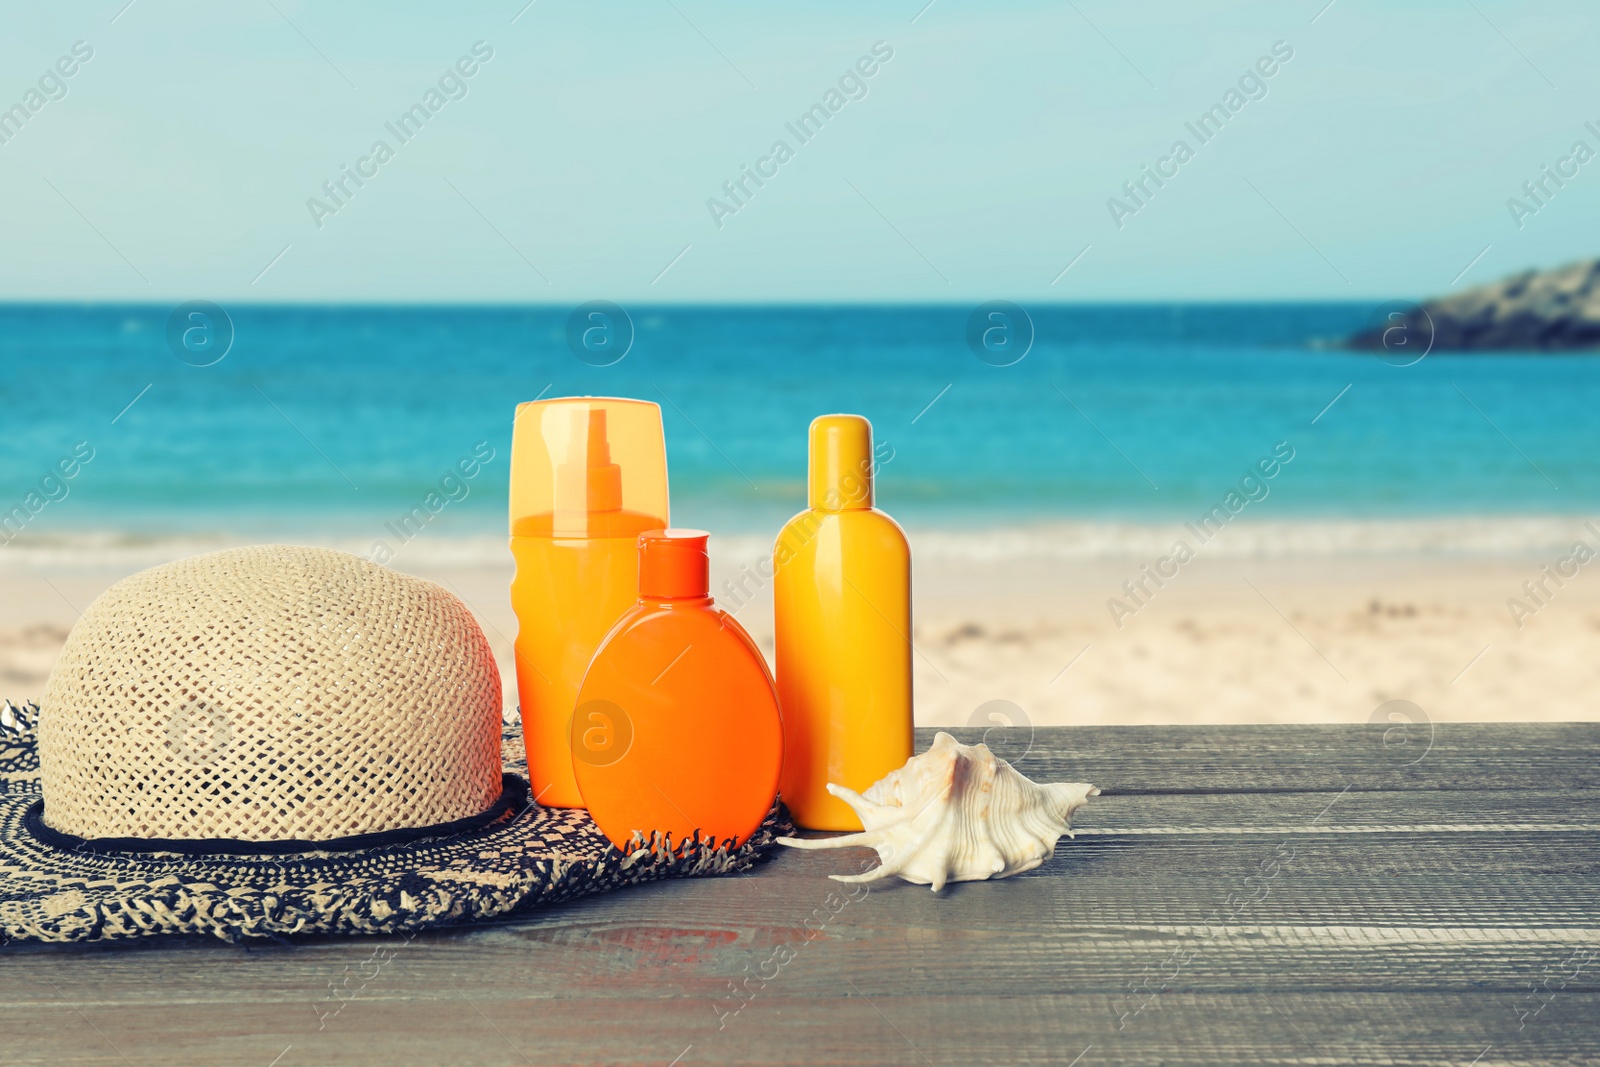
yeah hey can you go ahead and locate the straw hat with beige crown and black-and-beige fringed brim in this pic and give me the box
[0,545,786,941]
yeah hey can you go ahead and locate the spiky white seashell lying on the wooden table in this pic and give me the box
[778,731,1099,893]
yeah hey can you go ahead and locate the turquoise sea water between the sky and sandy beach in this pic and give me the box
[0,304,1600,541]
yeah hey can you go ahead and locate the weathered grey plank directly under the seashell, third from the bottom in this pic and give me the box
[6,825,1600,958]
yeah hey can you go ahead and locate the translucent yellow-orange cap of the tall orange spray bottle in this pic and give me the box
[510,397,667,537]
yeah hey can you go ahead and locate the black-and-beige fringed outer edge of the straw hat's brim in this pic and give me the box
[0,701,794,942]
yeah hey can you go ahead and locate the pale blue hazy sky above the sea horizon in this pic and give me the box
[0,0,1600,304]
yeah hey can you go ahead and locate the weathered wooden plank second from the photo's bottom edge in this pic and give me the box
[6,904,1600,1016]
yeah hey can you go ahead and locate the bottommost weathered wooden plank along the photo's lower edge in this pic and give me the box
[6,991,1600,1067]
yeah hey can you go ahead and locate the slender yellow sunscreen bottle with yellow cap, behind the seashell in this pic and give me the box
[773,414,912,830]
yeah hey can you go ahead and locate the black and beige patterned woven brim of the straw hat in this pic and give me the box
[0,723,794,942]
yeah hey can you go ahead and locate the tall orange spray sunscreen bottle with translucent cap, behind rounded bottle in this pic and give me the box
[510,397,667,808]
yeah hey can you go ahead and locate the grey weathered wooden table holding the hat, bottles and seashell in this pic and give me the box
[12,723,1600,1067]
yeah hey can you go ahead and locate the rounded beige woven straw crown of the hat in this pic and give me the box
[38,545,501,841]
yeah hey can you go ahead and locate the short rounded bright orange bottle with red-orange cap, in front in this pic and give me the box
[571,530,784,848]
